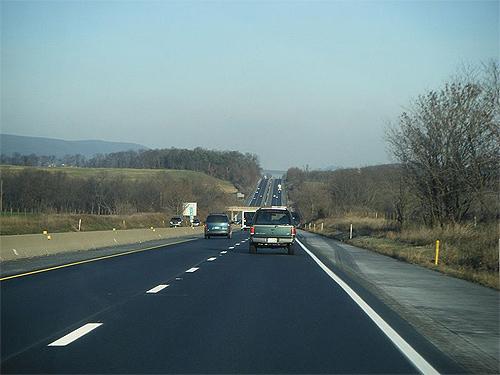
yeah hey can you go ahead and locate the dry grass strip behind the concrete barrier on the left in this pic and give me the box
[0,213,170,235]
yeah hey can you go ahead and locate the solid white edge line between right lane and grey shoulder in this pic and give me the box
[296,240,439,375]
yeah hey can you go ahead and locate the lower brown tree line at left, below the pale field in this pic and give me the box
[2,168,234,215]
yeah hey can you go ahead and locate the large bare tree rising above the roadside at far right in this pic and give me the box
[387,62,500,225]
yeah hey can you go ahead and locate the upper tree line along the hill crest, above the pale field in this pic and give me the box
[0,148,261,192]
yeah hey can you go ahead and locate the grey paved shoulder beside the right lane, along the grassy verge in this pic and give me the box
[299,231,500,373]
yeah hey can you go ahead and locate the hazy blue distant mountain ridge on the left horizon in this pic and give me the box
[0,134,148,158]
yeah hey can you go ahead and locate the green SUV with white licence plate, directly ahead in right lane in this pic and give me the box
[250,207,296,255]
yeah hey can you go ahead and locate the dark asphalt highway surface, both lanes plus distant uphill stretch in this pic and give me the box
[0,179,456,373]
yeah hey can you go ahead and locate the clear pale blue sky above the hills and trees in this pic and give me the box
[1,1,499,169]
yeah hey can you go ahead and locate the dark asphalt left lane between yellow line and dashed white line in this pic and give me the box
[0,240,220,360]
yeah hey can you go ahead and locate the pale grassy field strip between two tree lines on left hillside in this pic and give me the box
[0,165,237,194]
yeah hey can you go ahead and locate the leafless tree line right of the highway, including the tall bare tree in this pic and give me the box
[286,62,500,226]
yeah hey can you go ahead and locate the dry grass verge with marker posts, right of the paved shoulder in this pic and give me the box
[310,215,500,289]
